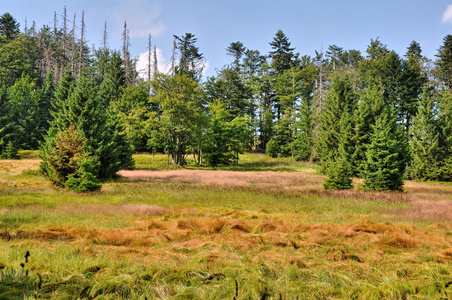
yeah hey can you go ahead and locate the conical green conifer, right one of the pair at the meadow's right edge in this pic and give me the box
[363,106,407,191]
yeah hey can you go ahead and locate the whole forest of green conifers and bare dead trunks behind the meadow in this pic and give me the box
[0,9,452,191]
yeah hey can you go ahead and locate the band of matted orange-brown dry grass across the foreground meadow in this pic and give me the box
[0,206,452,265]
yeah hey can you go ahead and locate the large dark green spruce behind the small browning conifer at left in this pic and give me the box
[41,72,132,190]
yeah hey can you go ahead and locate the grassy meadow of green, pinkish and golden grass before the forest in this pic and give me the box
[0,154,452,299]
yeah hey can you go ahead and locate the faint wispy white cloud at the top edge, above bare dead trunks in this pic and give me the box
[113,0,165,38]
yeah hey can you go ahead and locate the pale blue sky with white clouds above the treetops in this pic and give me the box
[0,0,452,76]
